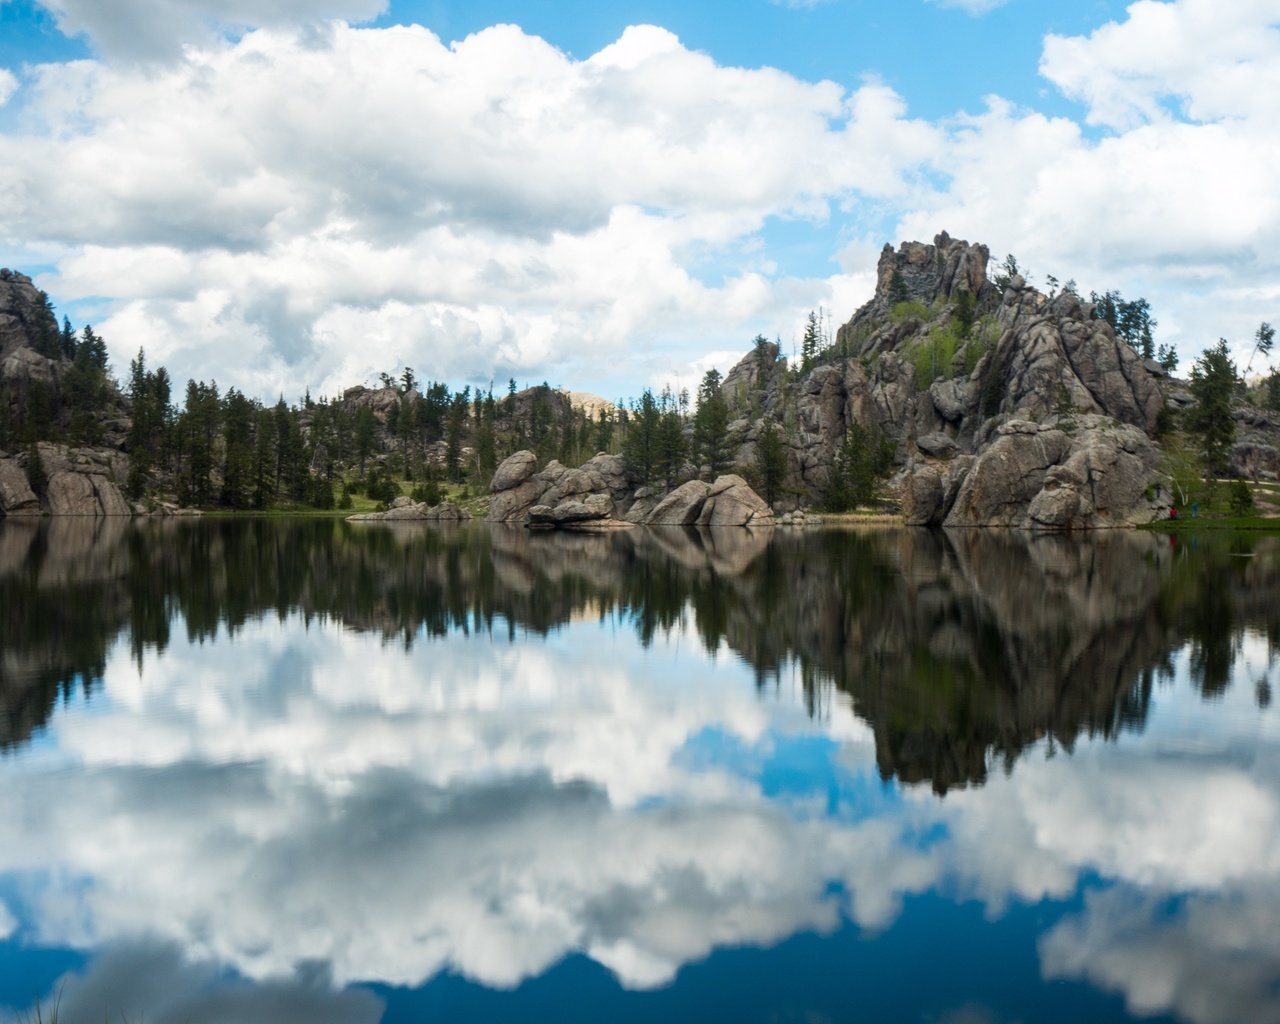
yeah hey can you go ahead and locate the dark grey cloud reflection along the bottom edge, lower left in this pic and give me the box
[45,945,383,1024]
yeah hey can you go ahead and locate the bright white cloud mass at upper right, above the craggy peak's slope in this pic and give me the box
[899,0,1280,368]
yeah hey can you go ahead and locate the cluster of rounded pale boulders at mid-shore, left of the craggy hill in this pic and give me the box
[486,452,773,530]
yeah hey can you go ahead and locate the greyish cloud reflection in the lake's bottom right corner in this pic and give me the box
[1041,887,1280,1024]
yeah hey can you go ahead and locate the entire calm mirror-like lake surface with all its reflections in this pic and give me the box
[0,520,1280,1024]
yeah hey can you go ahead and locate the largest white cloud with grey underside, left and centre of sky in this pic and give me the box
[0,26,938,394]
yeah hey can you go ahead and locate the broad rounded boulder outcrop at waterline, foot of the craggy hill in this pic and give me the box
[902,416,1161,530]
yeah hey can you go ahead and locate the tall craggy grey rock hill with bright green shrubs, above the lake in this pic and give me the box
[724,233,1164,530]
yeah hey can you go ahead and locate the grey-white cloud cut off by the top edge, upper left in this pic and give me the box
[37,0,387,59]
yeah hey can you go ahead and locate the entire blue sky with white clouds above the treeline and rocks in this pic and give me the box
[0,0,1280,401]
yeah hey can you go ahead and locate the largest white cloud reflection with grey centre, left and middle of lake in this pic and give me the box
[0,622,937,986]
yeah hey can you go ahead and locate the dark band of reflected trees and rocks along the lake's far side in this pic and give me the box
[0,520,1280,792]
